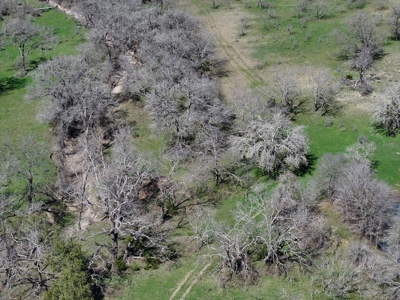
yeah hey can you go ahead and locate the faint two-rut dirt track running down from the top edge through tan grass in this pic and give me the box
[193,0,265,85]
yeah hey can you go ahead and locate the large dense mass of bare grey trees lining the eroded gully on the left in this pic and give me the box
[0,0,233,299]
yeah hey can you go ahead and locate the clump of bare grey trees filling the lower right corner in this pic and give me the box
[190,141,399,292]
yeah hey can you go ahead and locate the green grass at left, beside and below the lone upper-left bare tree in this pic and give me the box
[0,10,85,140]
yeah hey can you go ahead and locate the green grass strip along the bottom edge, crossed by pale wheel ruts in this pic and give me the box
[114,253,326,300]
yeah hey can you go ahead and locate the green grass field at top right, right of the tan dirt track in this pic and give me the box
[206,0,387,69]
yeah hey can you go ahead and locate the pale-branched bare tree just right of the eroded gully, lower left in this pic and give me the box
[90,129,168,260]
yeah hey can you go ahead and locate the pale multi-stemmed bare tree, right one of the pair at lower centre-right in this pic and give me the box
[255,173,329,272]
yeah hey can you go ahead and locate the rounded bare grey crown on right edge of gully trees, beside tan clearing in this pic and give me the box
[146,70,232,156]
